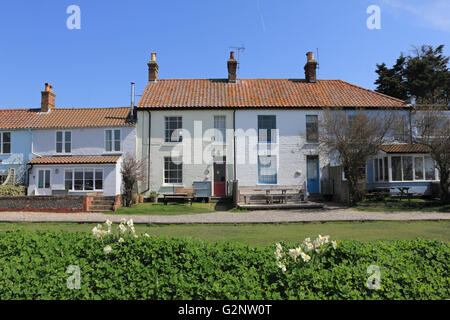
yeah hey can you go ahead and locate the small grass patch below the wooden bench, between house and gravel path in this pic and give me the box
[106,202,244,216]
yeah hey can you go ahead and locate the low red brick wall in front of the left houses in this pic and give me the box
[0,196,92,212]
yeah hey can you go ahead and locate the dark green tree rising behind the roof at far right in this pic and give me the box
[375,45,450,104]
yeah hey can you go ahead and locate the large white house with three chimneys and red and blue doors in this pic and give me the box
[137,52,407,196]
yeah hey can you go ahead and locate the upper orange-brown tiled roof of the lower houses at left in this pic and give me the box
[0,107,134,129]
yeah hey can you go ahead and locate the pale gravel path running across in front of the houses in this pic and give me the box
[0,208,450,224]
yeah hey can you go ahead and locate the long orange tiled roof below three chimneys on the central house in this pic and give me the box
[138,79,406,108]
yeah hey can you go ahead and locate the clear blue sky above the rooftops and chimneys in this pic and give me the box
[0,0,450,108]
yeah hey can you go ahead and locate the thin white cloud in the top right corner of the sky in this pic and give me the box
[383,0,450,32]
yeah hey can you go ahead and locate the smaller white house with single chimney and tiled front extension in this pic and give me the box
[23,85,136,196]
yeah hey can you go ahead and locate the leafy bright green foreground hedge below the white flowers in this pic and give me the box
[0,231,450,300]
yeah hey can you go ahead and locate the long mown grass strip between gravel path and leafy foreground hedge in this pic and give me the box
[0,221,450,246]
